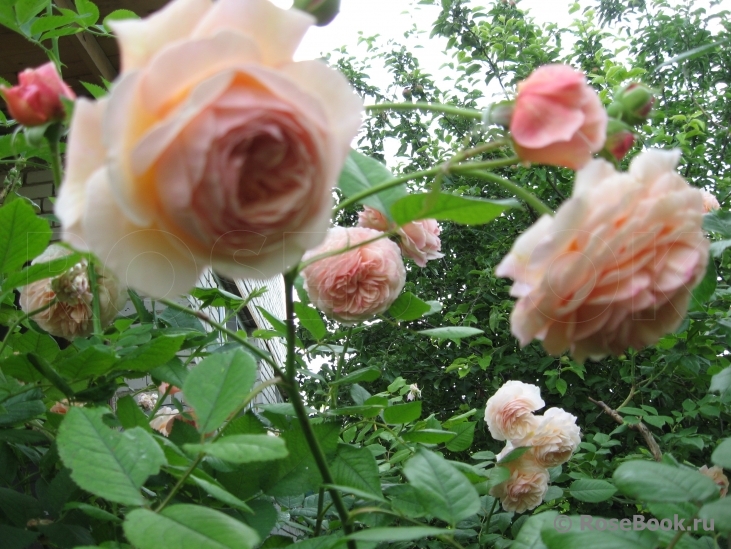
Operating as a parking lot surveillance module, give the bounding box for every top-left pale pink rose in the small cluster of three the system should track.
[485,380,546,440]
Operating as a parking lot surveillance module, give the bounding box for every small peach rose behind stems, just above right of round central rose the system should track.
[358,206,444,267]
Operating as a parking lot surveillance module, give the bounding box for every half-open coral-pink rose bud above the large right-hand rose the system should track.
[510,65,607,169]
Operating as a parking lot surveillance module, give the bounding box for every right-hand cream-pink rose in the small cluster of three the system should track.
[513,408,581,467]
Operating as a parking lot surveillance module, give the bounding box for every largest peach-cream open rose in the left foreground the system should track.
[56,0,362,297]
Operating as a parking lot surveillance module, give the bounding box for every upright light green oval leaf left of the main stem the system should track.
[183,349,257,433]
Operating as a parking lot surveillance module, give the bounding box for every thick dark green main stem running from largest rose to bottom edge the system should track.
[284,270,357,549]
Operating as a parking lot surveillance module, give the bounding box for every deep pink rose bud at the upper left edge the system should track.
[0,63,76,126]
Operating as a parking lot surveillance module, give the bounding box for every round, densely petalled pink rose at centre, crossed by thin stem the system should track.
[302,227,406,323]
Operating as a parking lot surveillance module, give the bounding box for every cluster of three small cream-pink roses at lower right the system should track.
[485,381,581,513]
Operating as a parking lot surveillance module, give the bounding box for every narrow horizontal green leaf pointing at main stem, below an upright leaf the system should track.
[185,435,288,463]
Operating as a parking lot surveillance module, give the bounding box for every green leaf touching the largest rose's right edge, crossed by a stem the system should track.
[338,150,406,219]
